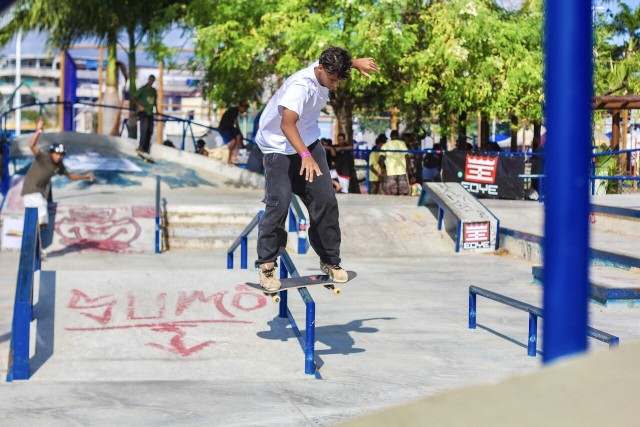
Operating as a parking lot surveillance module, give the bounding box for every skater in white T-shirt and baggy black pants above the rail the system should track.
[255,47,378,290]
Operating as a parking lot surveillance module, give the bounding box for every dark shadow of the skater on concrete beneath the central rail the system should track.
[257,317,395,356]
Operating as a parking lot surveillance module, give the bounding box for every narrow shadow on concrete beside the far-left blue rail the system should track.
[29,271,56,376]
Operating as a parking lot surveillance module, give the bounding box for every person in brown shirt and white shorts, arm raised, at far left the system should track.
[21,118,93,255]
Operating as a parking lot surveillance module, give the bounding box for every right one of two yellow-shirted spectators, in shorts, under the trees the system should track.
[380,130,409,196]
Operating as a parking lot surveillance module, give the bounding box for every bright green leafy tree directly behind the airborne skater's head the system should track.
[188,0,413,144]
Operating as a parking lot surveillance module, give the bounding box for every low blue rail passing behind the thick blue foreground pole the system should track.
[469,286,620,357]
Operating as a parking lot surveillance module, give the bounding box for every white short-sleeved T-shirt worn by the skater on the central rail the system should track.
[256,62,329,155]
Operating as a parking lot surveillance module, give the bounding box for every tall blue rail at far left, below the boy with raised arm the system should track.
[7,208,40,382]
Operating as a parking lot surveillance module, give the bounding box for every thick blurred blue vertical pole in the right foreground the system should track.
[543,0,593,363]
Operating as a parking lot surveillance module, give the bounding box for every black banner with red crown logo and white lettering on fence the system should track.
[442,151,524,200]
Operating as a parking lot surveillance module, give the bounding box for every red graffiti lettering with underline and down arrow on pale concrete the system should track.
[65,285,267,357]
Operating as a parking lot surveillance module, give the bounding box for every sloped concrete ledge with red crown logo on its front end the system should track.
[421,182,500,252]
